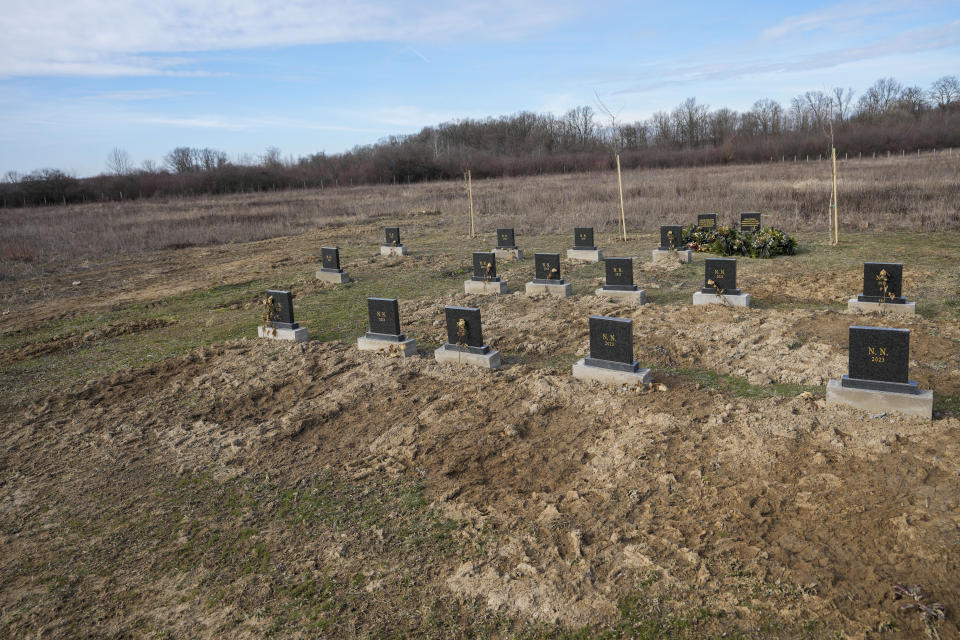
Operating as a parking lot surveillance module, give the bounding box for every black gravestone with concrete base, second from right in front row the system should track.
[573,316,650,384]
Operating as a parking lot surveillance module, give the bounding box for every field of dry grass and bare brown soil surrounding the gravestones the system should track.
[0,156,960,639]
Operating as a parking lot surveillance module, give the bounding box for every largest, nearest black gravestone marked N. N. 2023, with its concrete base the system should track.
[827,326,933,419]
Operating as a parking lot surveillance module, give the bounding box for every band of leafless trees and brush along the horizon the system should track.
[0,76,960,207]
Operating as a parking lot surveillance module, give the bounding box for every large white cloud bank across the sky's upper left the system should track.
[0,0,571,76]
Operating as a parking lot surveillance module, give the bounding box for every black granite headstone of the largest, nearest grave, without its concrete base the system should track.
[840,327,920,394]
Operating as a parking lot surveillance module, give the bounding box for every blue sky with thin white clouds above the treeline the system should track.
[0,0,960,176]
